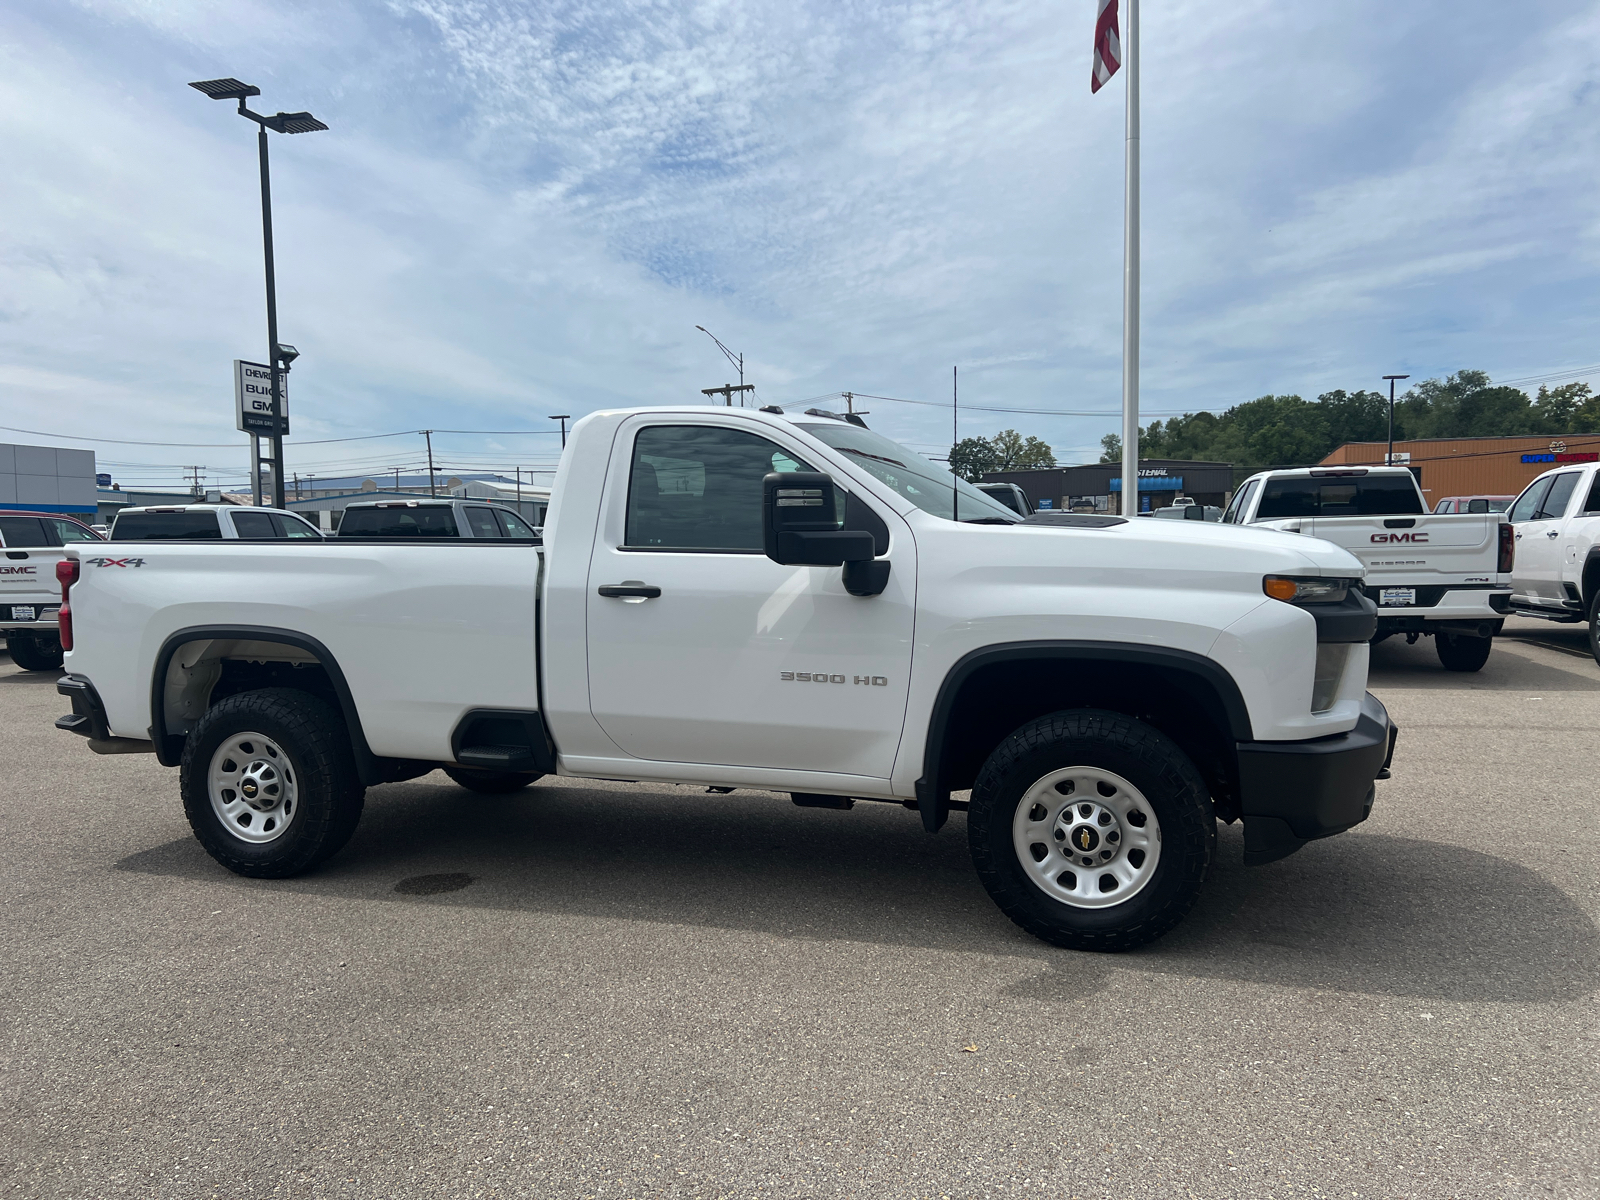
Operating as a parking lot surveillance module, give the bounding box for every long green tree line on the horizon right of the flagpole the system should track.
[1101,371,1600,472]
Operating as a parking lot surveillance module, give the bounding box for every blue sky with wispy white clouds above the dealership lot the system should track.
[0,0,1600,485]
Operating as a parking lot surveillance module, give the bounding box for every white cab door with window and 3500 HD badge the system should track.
[587,414,917,779]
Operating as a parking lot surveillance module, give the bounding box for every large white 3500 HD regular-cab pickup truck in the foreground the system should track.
[58,408,1395,949]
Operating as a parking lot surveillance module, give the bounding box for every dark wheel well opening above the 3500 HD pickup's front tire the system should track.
[926,656,1242,821]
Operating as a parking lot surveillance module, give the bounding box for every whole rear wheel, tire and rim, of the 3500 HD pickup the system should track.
[179,688,366,878]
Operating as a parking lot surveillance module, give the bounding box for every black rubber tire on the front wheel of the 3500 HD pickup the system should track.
[966,709,1216,950]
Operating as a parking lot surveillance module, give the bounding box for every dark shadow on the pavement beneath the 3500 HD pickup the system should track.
[117,776,1600,1002]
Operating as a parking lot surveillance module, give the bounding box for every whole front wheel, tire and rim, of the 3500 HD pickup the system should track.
[966,709,1216,950]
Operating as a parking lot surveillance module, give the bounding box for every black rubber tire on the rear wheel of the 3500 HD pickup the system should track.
[178,688,366,878]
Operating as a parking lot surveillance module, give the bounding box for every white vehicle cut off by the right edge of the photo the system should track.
[1510,454,1600,662]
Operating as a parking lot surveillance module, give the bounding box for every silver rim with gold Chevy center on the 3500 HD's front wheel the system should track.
[1011,766,1162,909]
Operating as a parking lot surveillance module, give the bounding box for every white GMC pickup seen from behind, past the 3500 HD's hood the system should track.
[1222,467,1514,670]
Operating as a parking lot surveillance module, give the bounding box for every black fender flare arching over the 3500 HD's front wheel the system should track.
[915,640,1254,834]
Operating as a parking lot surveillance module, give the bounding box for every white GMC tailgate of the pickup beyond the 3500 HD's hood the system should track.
[1301,512,1504,586]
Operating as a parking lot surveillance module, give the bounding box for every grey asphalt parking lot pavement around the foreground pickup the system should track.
[0,621,1600,1198]
